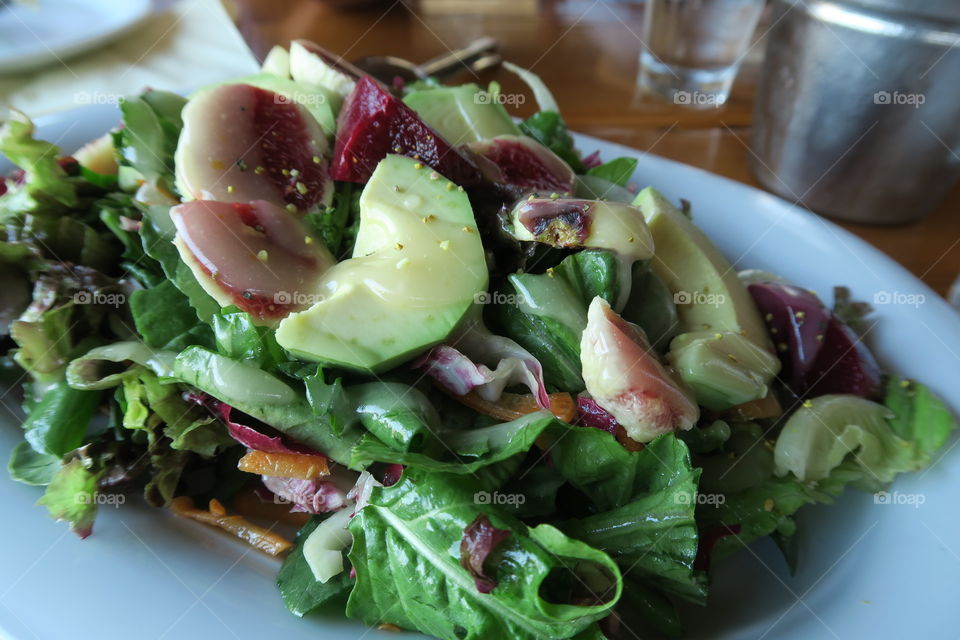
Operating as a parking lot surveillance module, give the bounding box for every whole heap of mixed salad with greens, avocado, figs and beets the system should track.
[0,41,956,640]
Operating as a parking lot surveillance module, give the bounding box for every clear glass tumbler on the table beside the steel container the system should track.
[640,0,764,109]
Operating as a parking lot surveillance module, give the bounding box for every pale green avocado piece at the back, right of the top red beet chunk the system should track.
[403,84,520,145]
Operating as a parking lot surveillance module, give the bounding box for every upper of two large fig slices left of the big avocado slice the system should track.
[175,84,333,211]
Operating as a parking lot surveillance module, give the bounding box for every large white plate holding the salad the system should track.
[0,105,960,640]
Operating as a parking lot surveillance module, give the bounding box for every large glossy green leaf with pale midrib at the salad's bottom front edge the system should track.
[347,472,621,640]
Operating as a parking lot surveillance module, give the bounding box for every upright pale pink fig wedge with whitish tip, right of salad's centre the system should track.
[580,296,700,442]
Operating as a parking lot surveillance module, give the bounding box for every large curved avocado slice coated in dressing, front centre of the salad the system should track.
[277,155,487,372]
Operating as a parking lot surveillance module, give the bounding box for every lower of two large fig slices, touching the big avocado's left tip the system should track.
[170,200,334,323]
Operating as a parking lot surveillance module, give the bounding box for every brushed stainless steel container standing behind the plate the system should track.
[751,0,960,224]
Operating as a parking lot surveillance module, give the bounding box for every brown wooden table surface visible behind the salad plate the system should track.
[230,0,960,295]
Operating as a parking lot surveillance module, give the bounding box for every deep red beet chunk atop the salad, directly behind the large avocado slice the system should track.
[330,76,481,186]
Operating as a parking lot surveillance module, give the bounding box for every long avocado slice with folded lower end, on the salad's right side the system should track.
[633,187,780,411]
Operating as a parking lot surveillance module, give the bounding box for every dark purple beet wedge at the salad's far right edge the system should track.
[747,282,880,398]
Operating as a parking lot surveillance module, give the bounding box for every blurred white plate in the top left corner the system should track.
[0,0,152,73]
